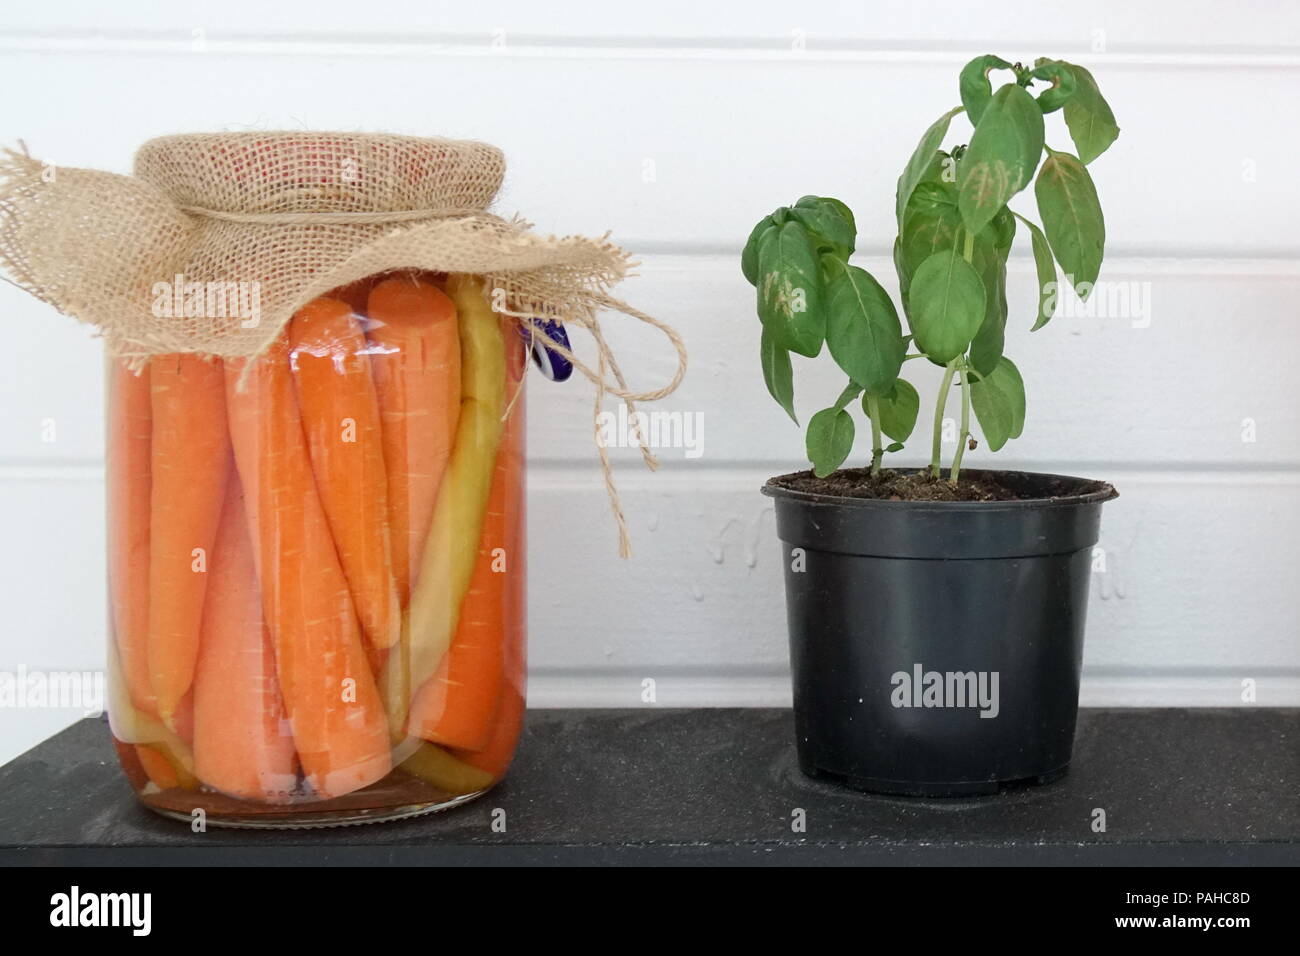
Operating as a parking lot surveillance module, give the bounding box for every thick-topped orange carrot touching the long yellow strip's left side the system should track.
[367,276,460,606]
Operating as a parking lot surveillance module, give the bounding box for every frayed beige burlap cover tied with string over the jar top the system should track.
[0,133,686,555]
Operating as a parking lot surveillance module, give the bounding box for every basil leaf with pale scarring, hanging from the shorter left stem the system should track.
[758,221,826,358]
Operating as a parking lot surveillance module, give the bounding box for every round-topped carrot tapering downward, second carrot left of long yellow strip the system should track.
[289,299,402,658]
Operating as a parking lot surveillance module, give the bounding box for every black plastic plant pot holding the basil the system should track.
[763,470,1117,796]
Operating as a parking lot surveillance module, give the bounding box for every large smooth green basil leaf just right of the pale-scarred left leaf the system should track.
[826,265,905,389]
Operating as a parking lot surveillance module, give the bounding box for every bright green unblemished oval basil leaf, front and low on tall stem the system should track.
[907,248,985,364]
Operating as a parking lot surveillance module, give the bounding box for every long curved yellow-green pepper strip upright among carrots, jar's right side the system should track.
[381,276,506,737]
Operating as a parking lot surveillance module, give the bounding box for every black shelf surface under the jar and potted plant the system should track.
[0,708,1300,866]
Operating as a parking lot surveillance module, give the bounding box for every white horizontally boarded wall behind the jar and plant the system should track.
[0,0,1300,760]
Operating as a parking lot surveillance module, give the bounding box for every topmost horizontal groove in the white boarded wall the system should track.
[0,32,1300,70]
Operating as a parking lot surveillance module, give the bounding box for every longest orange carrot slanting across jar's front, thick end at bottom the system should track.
[226,339,391,797]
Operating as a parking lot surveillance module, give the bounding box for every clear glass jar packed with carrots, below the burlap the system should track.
[107,272,525,827]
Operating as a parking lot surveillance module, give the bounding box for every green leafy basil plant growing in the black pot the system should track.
[741,55,1119,484]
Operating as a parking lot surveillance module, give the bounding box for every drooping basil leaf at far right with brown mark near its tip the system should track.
[1034,152,1106,299]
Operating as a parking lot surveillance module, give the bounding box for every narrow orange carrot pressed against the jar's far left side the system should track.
[107,362,157,714]
